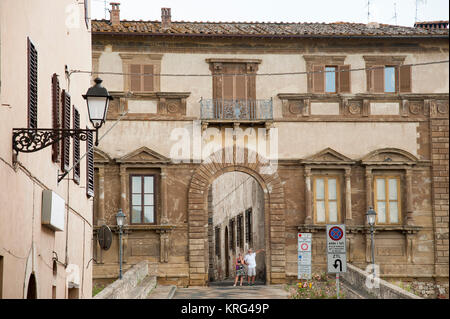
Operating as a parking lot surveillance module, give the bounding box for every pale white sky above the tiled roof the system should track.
[91,0,449,26]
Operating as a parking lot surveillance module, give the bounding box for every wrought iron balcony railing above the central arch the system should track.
[200,99,273,121]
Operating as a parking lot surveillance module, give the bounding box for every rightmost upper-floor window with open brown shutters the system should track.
[363,56,412,93]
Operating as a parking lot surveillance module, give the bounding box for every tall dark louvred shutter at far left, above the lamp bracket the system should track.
[28,38,38,128]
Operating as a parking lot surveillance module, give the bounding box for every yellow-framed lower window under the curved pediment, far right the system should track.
[374,176,401,224]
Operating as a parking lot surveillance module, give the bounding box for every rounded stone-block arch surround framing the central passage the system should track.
[188,147,286,286]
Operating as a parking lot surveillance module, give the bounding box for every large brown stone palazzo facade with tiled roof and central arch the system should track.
[92,5,449,285]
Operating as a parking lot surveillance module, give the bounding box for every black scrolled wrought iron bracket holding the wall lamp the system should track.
[12,128,97,154]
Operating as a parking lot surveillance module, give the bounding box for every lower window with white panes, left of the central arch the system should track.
[131,175,155,224]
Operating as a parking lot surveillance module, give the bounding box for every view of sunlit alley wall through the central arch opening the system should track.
[208,171,266,283]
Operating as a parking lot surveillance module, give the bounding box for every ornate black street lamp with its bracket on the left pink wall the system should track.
[12,78,113,154]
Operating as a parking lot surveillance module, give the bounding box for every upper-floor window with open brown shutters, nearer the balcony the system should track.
[303,55,351,93]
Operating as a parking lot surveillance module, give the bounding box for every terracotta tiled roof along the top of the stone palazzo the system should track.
[92,20,449,37]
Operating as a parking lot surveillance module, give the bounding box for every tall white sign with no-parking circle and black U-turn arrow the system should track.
[326,225,347,273]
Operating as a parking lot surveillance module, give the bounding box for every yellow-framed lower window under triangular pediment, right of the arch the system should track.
[313,176,340,224]
